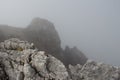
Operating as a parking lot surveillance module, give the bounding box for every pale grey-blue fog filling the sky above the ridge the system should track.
[0,0,120,65]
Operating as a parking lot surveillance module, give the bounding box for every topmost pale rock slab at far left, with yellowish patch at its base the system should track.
[0,38,34,51]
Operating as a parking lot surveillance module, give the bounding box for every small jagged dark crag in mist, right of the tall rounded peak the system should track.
[64,46,87,65]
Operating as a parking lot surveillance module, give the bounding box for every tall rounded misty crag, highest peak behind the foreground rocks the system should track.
[24,18,61,57]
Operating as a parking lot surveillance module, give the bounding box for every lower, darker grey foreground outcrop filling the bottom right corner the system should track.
[69,60,120,80]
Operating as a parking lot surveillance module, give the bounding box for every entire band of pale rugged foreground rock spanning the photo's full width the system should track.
[0,38,120,80]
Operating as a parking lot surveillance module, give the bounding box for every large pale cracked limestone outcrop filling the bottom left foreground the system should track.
[0,38,69,80]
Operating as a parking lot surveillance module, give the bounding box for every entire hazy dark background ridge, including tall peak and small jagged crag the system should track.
[0,18,87,65]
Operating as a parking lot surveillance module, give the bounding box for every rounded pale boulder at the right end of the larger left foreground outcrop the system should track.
[46,56,68,80]
